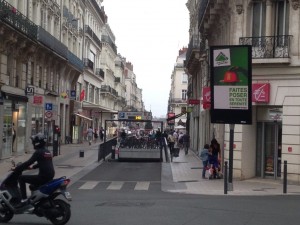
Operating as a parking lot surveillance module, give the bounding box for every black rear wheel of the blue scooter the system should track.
[49,199,71,225]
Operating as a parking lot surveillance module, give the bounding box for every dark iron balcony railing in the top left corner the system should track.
[0,0,37,41]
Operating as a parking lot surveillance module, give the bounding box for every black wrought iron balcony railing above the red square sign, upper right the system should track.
[240,35,292,59]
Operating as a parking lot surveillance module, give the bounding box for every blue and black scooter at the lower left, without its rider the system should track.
[0,161,72,225]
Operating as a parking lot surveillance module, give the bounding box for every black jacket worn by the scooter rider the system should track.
[15,148,55,179]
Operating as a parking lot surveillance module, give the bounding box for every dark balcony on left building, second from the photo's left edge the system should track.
[37,26,68,58]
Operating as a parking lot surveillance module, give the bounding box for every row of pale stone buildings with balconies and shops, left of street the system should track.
[0,0,142,159]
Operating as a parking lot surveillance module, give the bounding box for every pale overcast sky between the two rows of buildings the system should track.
[102,0,189,117]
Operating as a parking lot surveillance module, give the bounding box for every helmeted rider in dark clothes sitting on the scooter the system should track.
[14,133,55,205]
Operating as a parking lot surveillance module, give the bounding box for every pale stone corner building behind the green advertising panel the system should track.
[185,0,300,183]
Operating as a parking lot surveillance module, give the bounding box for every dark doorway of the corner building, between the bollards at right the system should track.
[256,121,282,179]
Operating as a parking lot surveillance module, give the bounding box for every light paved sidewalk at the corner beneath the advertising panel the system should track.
[163,151,300,196]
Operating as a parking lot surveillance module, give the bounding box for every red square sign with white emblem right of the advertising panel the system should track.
[252,83,270,103]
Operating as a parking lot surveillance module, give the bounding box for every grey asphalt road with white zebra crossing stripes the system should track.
[10,162,300,225]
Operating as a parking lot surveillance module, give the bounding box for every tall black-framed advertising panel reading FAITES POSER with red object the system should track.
[210,45,252,124]
